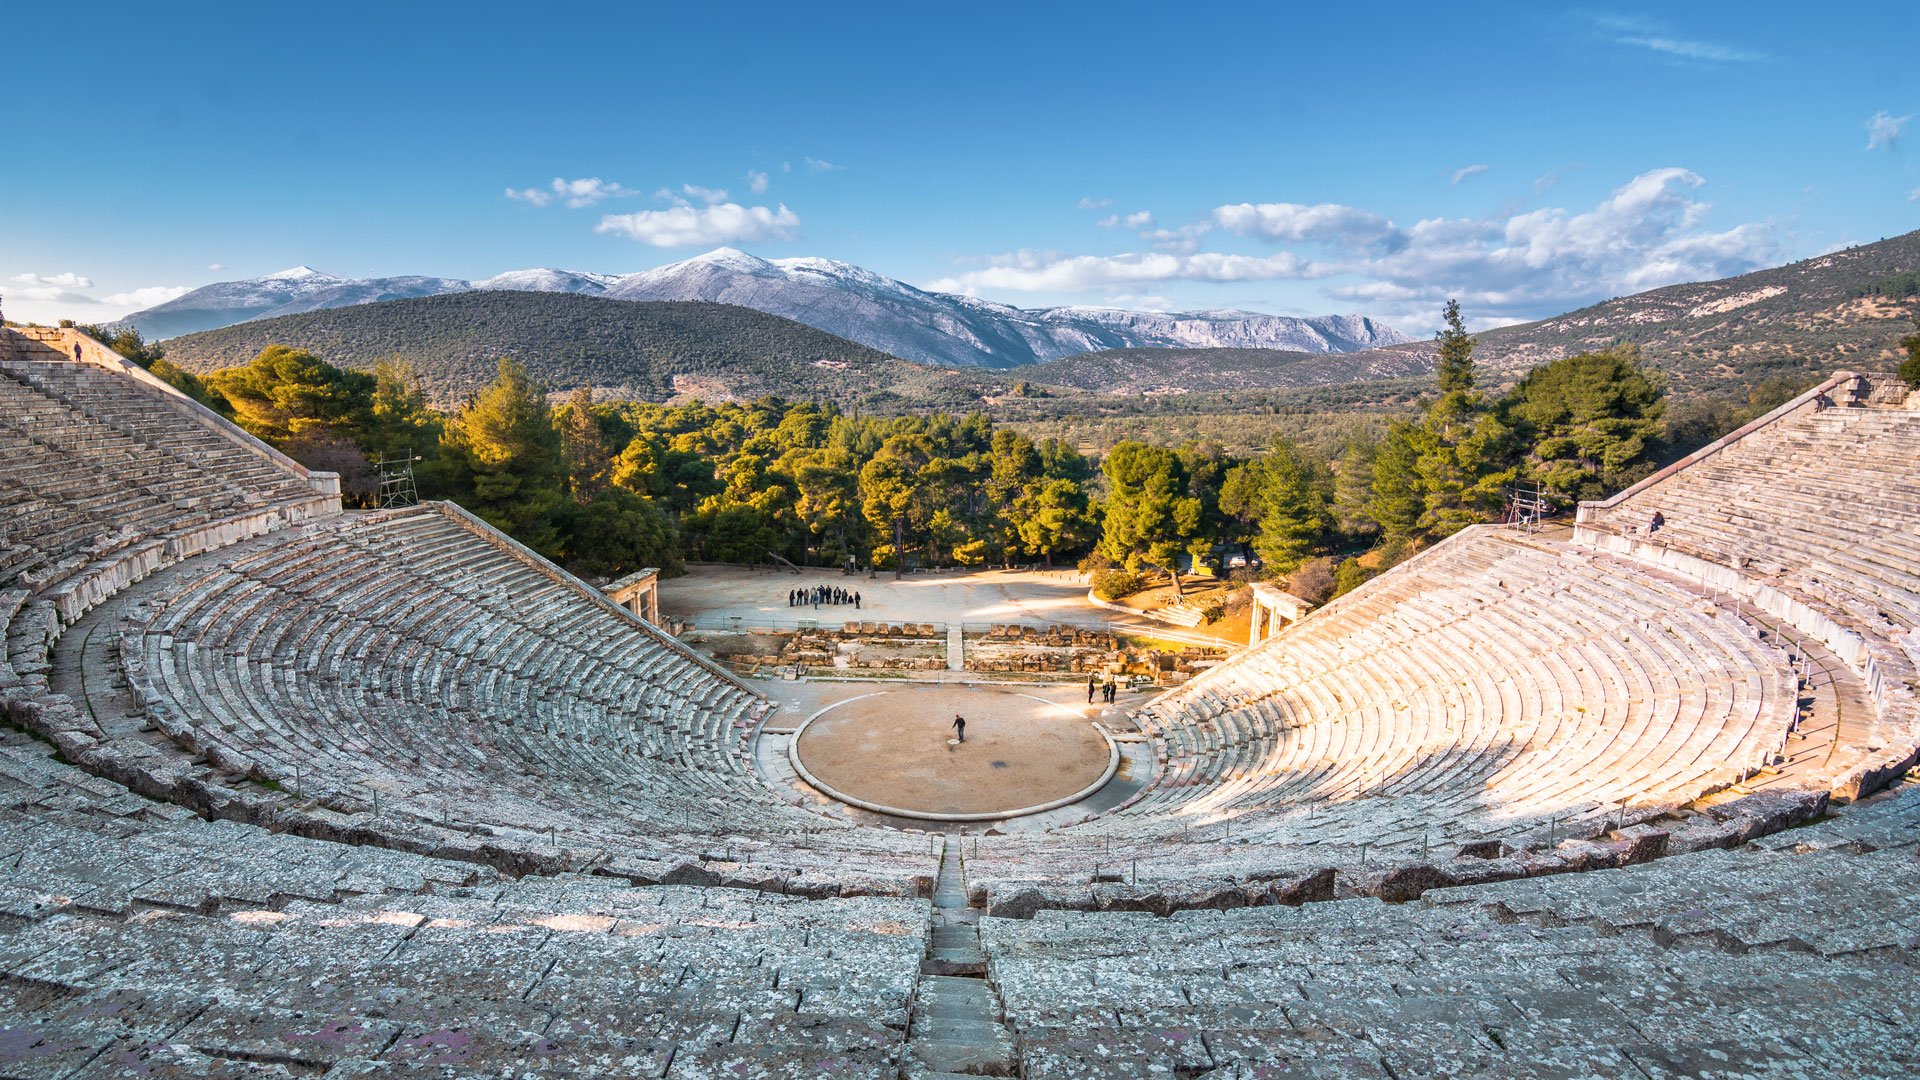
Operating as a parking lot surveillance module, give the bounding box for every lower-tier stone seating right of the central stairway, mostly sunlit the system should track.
[973,528,1795,892]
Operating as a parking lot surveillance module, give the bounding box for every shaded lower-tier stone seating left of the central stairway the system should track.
[104,505,929,892]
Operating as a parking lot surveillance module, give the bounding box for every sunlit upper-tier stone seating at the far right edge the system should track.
[1574,373,1920,794]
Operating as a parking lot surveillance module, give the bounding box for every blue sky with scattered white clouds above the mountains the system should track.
[0,2,1920,332]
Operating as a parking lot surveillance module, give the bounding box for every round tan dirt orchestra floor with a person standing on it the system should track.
[799,684,1108,813]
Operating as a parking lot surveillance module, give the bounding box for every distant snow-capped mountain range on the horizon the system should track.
[123,248,1409,367]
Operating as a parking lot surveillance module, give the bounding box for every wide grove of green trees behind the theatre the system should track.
[60,304,1795,600]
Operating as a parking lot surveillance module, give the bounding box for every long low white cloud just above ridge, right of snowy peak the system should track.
[927,250,1325,294]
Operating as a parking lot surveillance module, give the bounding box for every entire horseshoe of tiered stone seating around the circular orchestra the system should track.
[0,331,1920,1080]
